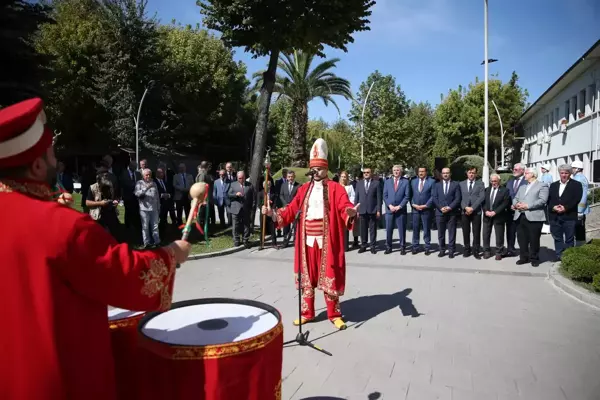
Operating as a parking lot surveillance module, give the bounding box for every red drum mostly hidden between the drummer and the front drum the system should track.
[108,308,145,400]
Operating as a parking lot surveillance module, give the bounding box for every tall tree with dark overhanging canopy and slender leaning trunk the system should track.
[197,0,375,189]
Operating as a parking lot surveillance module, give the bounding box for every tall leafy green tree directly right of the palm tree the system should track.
[350,71,410,170]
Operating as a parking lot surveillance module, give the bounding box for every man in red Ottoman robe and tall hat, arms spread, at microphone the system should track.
[262,139,358,329]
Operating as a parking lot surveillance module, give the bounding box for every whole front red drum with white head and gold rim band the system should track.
[138,299,283,400]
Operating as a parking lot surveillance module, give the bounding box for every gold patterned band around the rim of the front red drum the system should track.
[169,322,283,360]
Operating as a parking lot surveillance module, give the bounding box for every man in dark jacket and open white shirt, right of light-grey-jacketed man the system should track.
[548,164,583,261]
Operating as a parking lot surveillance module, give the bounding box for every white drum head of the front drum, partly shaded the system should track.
[139,299,281,346]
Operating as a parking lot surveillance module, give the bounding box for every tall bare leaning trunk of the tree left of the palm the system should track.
[250,50,279,194]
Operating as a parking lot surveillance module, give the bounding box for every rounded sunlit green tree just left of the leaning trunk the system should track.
[159,25,251,150]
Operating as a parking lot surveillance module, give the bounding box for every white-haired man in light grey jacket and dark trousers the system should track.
[511,168,549,267]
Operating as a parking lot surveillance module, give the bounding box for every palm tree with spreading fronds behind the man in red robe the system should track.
[254,50,352,168]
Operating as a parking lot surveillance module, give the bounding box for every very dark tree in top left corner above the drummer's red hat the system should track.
[0,0,51,107]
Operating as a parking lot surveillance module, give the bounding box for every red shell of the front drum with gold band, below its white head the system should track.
[139,300,283,400]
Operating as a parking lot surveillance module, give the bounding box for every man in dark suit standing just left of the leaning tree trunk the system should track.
[227,171,256,248]
